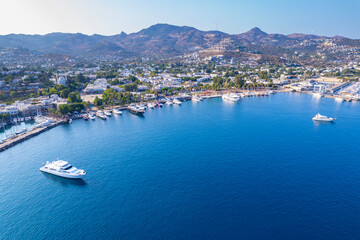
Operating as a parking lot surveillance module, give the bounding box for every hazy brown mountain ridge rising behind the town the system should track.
[0,23,360,56]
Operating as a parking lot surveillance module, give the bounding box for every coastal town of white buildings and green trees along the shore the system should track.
[0,56,360,150]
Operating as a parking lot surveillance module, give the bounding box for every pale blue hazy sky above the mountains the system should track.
[0,0,360,38]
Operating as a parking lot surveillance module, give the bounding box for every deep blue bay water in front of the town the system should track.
[0,93,360,240]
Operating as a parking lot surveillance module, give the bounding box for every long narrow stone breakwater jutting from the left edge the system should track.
[0,121,65,152]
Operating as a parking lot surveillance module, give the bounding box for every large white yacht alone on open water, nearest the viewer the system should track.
[40,159,86,178]
